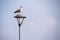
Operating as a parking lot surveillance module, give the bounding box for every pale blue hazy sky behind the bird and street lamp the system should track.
[0,0,60,40]
